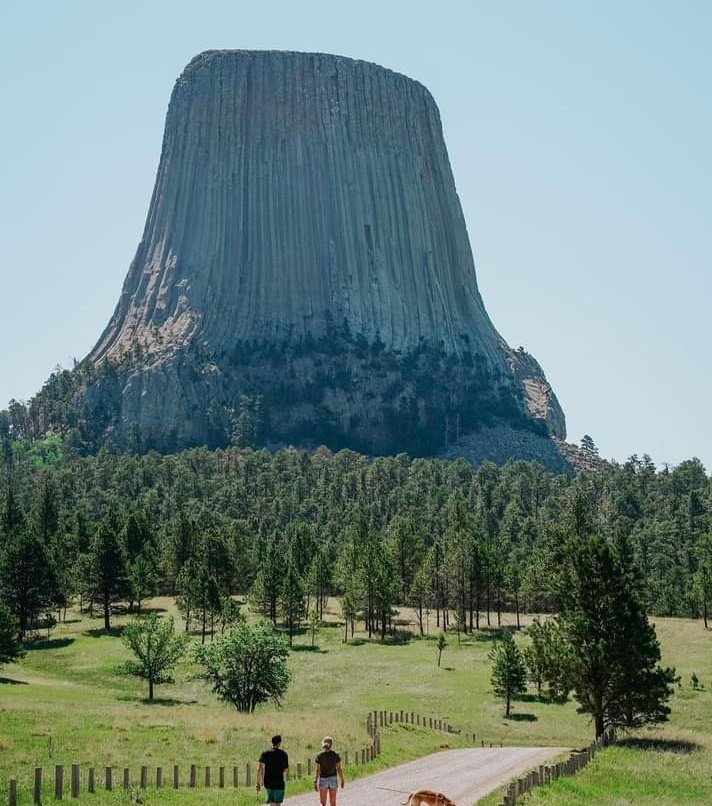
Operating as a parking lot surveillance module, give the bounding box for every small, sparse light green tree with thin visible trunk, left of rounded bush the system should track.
[121,613,188,700]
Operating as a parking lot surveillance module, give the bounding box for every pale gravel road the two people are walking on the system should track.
[285,747,562,806]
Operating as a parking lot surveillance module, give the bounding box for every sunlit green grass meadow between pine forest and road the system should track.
[0,599,712,806]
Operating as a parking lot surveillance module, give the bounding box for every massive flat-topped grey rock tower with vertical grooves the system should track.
[82,51,565,468]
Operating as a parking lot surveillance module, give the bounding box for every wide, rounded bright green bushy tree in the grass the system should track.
[195,624,290,713]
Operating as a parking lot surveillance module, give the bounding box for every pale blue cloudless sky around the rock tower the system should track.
[0,0,712,469]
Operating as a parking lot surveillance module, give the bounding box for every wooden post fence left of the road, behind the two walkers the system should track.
[8,711,456,806]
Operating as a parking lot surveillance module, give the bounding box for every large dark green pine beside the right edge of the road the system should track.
[557,508,677,736]
